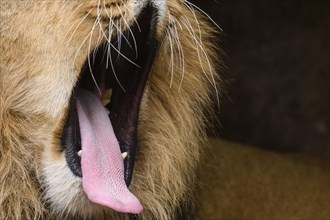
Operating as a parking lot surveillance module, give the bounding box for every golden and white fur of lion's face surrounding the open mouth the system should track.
[0,0,218,220]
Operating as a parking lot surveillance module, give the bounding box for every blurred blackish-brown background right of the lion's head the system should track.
[191,0,330,156]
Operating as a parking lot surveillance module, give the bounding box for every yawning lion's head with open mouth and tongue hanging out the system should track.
[0,0,219,220]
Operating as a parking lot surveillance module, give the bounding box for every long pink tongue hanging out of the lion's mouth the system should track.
[77,90,143,214]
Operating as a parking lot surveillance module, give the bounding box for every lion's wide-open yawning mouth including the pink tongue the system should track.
[62,6,157,213]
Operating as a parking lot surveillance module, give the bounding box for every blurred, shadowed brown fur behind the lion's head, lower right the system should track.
[198,140,330,220]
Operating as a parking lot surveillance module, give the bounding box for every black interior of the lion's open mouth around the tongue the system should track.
[62,6,157,185]
